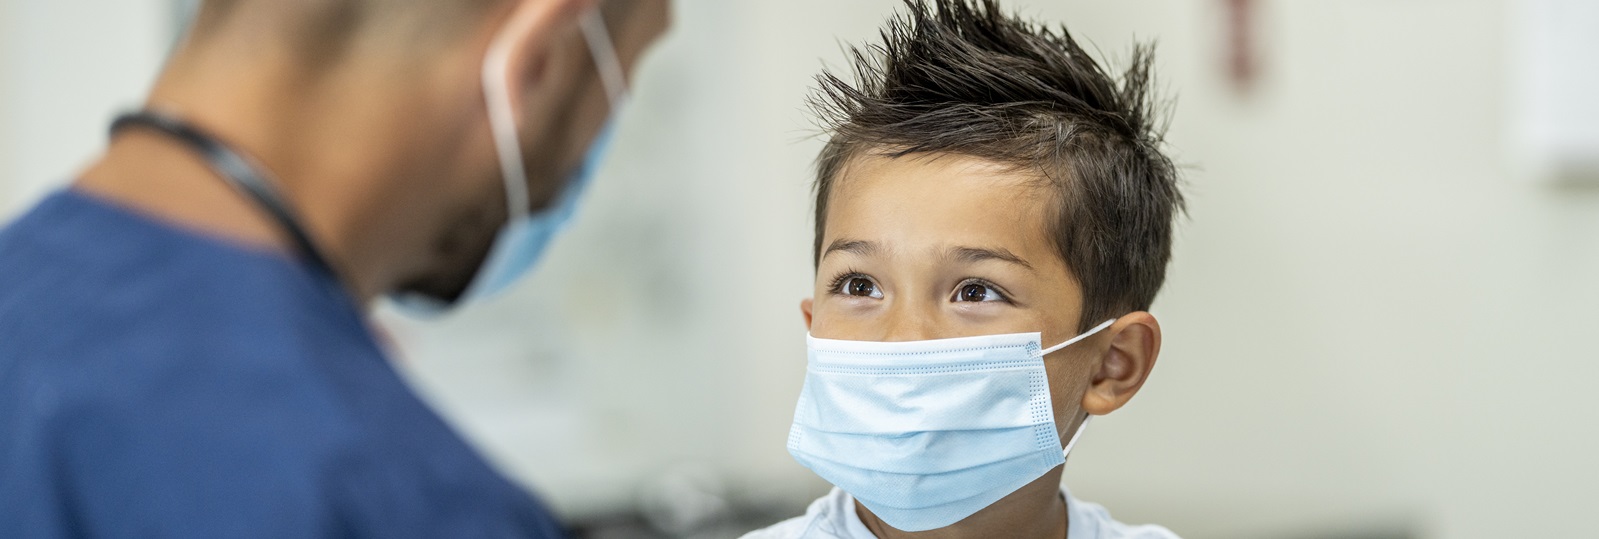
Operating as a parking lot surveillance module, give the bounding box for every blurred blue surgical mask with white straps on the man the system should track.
[395,10,627,315]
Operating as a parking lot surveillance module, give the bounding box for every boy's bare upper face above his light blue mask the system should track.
[803,154,1099,440]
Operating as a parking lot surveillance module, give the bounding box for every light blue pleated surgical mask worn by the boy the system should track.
[788,321,1111,531]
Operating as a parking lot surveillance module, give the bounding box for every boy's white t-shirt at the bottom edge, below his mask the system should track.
[742,486,1178,539]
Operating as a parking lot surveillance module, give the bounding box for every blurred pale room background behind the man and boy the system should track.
[0,0,1599,539]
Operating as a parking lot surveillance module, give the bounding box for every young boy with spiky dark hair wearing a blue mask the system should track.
[747,0,1182,539]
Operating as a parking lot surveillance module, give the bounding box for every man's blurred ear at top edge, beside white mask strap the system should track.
[489,0,598,118]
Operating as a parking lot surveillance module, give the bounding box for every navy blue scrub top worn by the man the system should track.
[0,190,561,537]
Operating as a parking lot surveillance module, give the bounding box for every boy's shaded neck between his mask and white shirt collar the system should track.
[855,467,1067,539]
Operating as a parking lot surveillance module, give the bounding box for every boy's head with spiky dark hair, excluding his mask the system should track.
[803,0,1182,440]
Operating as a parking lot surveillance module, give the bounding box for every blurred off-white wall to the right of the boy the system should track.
[1029,2,1599,537]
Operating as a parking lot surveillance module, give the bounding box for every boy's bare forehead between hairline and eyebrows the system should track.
[823,154,1054,257]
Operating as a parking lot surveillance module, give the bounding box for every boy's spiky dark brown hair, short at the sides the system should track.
[811,0,1183,329]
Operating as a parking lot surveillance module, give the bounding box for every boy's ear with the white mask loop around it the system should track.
[1083,310,1161,416]
